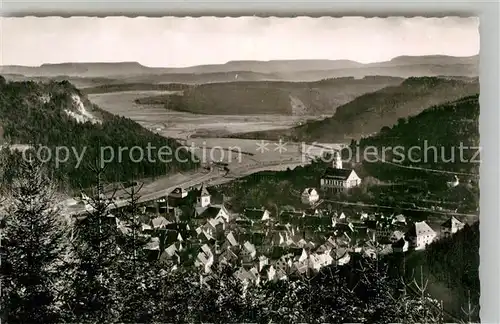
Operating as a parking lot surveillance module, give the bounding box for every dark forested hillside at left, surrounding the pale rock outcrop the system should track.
[0,80,196,188]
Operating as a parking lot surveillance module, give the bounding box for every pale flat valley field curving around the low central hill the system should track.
[88,91,310,139]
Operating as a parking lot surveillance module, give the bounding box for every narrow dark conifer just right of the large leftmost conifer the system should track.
[66,164,119,323]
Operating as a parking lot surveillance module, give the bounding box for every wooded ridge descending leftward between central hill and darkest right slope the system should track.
[232,77,479,143]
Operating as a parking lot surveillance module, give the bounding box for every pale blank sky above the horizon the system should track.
[0,17,479,67]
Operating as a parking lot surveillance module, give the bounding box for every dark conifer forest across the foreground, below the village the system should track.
[0,163,477,324]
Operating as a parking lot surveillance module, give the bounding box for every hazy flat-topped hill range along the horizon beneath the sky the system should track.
[0,55,479,83]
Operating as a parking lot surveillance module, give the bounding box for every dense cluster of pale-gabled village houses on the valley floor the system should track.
[102,185,464,284]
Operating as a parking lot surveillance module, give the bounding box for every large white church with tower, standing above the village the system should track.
[320,152,361,193]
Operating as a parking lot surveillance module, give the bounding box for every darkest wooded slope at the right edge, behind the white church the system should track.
[358,95,480,177]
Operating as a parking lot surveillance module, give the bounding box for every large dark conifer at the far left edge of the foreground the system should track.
[1,162,67,323]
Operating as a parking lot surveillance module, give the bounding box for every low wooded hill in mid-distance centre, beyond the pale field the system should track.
[136,76,403,115]
